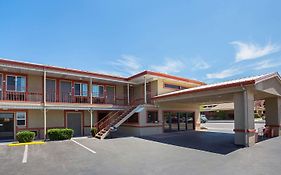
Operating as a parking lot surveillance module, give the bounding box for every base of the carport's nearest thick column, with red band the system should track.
[234,129,256,147]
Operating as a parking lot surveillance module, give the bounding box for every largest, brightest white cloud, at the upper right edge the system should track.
[230,41,280,62]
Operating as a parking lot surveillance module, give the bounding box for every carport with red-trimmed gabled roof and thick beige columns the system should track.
[154,73,281,146]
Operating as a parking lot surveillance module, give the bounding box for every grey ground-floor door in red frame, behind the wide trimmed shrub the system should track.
[66,112,82,137]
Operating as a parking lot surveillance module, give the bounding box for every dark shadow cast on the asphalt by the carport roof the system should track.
[139,131,243,155]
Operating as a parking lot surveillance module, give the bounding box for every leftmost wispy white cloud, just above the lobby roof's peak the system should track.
[111,54,142,75]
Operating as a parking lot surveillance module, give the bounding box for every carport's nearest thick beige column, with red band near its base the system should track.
[234,89,255,147]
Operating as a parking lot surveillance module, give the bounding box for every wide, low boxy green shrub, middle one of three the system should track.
[47,128,74,140]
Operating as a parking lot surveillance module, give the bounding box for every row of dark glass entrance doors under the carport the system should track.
[163,112,195,132]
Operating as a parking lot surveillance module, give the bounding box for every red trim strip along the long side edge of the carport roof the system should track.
[152,80,255,99]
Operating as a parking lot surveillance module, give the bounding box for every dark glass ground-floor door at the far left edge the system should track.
[0,113,14,140]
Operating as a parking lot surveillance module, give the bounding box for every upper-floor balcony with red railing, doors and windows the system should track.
[0,73,128,105]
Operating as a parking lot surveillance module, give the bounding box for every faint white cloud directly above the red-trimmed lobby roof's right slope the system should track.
[151,58,185,73]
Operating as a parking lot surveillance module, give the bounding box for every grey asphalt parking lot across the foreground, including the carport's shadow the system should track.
[0,121,281,175]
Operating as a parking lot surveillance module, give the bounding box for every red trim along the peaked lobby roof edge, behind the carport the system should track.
[127,71,205,85]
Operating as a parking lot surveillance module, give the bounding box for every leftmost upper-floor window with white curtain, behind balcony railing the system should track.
[7,75,26,92]
